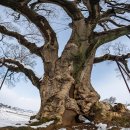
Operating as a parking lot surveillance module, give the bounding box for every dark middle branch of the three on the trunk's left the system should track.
[0,25,41,56]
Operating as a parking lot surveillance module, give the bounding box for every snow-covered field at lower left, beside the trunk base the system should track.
[0,107,34,127]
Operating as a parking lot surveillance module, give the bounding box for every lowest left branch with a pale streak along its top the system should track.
[0,58,40,88]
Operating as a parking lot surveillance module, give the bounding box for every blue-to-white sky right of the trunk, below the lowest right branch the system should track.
[92,62,130,103]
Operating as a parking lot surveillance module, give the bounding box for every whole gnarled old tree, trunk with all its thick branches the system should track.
[0,0,130,128]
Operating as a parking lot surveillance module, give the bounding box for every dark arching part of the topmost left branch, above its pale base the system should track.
[0,0,56,44]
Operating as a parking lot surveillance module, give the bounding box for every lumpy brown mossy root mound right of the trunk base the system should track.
[88,102,130,128]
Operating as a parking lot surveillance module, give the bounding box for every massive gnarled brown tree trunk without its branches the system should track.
[37,20,99,125]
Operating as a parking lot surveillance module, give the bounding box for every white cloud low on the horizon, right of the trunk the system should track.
[96,78,130,103]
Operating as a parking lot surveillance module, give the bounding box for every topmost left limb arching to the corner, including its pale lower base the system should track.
[0,0,58,67]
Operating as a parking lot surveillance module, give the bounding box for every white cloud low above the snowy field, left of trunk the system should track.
[0,86,40,111]
